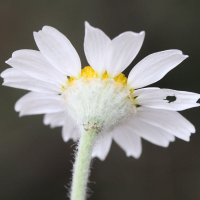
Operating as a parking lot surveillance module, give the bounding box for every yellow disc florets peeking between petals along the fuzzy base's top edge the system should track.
[69,66,127,86]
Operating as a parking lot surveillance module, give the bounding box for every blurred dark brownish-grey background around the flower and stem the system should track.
[0,0,200,200]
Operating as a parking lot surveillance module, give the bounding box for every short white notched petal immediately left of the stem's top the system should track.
[62,114,80,142]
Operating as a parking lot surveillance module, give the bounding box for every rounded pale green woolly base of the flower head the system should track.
[62,77,136,137]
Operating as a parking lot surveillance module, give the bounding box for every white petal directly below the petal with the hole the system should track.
[137,107,192,141]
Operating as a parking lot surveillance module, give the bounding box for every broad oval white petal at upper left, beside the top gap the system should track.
[34,26,81,77]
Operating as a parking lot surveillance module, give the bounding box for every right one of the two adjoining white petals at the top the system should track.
[105,31,145,78]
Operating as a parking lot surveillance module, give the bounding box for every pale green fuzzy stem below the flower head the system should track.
[71,129,97,200]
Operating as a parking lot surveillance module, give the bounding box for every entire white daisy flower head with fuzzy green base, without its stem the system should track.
[1,22,200,160]
